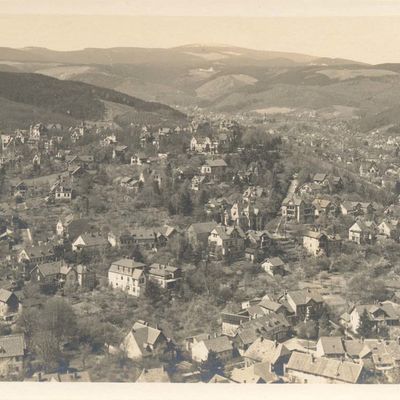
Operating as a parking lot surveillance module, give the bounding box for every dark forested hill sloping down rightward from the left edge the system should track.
[0,72,185,128]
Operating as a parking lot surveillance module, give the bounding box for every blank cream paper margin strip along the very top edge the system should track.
[0,0,400,16]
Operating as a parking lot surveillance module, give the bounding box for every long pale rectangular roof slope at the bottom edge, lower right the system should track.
[286,351,363,383]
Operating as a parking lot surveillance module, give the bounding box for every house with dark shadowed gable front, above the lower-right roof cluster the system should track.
[279,289,324,321]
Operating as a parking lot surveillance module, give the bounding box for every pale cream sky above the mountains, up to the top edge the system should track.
[0,0,400,63]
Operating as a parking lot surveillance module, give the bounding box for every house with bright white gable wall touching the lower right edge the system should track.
[348,303,400,333]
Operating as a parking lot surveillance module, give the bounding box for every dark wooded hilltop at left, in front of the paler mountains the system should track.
[0,71,184,127]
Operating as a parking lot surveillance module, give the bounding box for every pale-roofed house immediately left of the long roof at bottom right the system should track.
[243,337,290,375]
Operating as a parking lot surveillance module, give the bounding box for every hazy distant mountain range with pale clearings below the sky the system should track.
[0,44,400,129]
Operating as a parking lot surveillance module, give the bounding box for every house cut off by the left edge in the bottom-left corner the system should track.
[0,334,26,377]
